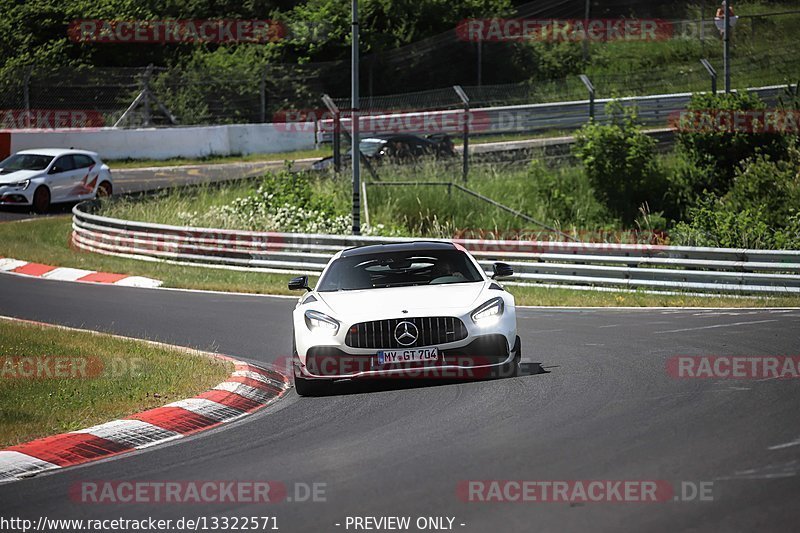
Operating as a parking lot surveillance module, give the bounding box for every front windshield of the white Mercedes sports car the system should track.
[317,250,483,292]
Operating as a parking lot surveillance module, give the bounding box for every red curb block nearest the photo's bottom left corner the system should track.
[6,433,133,466]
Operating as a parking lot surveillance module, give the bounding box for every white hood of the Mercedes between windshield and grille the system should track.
[317,282,487,322]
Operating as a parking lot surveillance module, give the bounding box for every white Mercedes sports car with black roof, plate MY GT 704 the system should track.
[289,241,521,395]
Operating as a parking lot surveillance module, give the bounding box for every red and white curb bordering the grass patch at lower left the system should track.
[0,320,290,483]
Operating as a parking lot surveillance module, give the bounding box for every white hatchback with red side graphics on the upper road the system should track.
[0,148,113,213]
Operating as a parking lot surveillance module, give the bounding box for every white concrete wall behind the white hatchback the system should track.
[11,124,314,159]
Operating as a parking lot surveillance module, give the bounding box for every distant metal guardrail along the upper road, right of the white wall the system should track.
[316,85,792,142]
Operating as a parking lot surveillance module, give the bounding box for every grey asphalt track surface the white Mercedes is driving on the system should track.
[0,275,800,532]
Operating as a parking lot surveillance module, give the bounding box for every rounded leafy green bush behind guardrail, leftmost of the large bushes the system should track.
[573,101,664,224]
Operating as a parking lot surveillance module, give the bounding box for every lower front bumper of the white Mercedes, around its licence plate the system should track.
[294,334,515,380]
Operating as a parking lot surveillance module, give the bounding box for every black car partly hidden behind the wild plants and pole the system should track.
[311,133,456,170]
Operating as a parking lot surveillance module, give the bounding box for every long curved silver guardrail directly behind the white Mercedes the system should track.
[72,202,800,295]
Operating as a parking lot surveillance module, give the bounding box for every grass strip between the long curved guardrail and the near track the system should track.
[0,217,800,308]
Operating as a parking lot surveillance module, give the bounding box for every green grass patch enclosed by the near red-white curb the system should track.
[0,320,233,447]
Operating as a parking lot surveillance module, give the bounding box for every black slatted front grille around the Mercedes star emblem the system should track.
[344,316,467,349]
